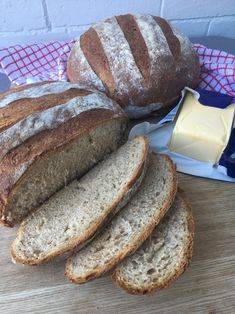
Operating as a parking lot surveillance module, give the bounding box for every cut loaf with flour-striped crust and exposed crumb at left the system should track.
[0,82,128,226]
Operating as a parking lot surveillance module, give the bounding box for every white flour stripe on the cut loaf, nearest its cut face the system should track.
[0,91,119,160]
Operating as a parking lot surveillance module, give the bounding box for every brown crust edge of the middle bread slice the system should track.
[65,153,177,283]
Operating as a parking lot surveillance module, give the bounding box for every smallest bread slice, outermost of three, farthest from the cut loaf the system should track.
[112,191,194,294]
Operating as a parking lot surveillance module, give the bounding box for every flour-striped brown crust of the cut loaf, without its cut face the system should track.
[0,82,127,226]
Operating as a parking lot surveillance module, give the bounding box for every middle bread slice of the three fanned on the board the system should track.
[65,153,177,283]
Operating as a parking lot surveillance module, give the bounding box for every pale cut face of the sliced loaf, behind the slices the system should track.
[0,117,127,227]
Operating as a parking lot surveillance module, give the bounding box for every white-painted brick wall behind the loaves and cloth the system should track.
[0,0,235,47]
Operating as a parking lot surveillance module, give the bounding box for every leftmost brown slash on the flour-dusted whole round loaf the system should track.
[80,27,115,97]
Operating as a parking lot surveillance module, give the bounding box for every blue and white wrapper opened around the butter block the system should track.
[129,87,235,182]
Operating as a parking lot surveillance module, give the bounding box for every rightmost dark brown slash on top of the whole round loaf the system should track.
[153,16,181,61]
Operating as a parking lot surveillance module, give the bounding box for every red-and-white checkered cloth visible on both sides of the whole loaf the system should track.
[0,40,235,98]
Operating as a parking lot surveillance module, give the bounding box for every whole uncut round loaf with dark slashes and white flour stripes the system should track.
[67,14,200,118]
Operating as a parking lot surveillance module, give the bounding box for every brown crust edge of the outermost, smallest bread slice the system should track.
[112,188,195,295]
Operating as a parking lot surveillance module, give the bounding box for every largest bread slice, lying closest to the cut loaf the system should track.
[12,136,149,265]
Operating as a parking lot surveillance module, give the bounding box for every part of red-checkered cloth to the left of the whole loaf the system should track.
[0,40,75,85]
